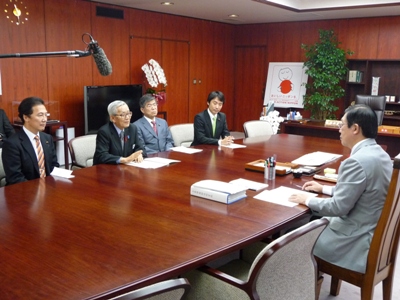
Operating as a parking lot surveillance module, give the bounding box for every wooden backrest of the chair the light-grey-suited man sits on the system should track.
[365,154,400,283]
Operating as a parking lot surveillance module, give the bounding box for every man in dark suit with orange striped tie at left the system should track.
[2,97,60,185]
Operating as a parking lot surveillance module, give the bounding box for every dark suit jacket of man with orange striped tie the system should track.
[2,129,60,185]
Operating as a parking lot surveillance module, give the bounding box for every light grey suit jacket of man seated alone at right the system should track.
[308,139,393,273]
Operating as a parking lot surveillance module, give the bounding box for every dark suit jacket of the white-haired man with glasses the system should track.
[93,122,146,165]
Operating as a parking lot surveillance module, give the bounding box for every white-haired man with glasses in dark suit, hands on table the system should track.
[93,100,146,165]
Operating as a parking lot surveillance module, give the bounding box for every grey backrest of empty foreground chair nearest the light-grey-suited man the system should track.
[248,218,329,300]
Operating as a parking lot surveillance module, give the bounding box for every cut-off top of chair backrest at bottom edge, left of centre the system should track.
[110,278,190,300]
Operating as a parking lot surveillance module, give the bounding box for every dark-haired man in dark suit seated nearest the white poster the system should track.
[192,91,233,146]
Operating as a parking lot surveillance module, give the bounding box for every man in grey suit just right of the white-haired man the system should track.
[133,94,174,154]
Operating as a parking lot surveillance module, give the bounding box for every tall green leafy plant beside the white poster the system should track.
[301,29,353,120]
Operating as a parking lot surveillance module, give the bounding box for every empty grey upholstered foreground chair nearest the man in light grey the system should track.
[185,219,328,300]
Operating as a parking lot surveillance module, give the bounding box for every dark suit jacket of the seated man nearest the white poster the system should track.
[191,109,230,146]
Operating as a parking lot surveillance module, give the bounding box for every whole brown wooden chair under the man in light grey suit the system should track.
[316,158,400,300]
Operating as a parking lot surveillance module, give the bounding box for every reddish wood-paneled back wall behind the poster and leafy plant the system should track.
[233,16,400,130]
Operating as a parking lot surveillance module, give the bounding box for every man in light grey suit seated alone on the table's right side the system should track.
[290,105,392,273]
